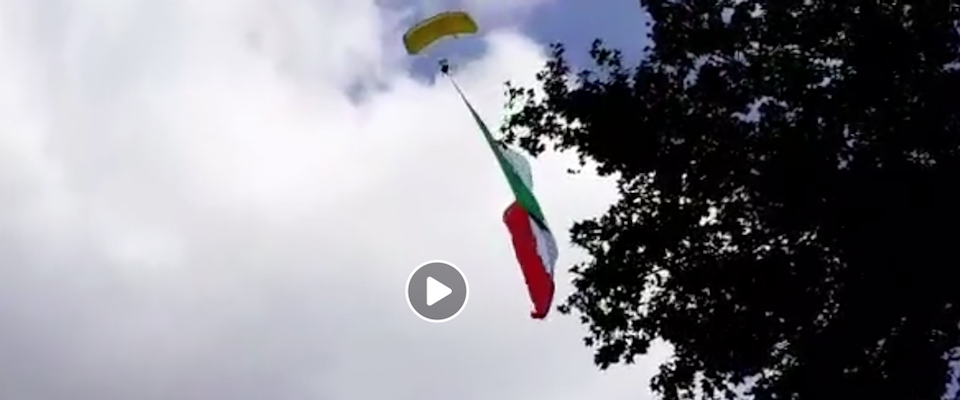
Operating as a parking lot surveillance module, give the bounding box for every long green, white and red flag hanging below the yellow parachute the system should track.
[451,78,558,319]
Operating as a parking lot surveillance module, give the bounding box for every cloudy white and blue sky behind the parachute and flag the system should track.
[0,0,668,400]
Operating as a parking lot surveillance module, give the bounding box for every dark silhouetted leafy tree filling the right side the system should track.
[503,0,960,400]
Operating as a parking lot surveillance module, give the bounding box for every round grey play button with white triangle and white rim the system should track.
[407,261,469,322]
